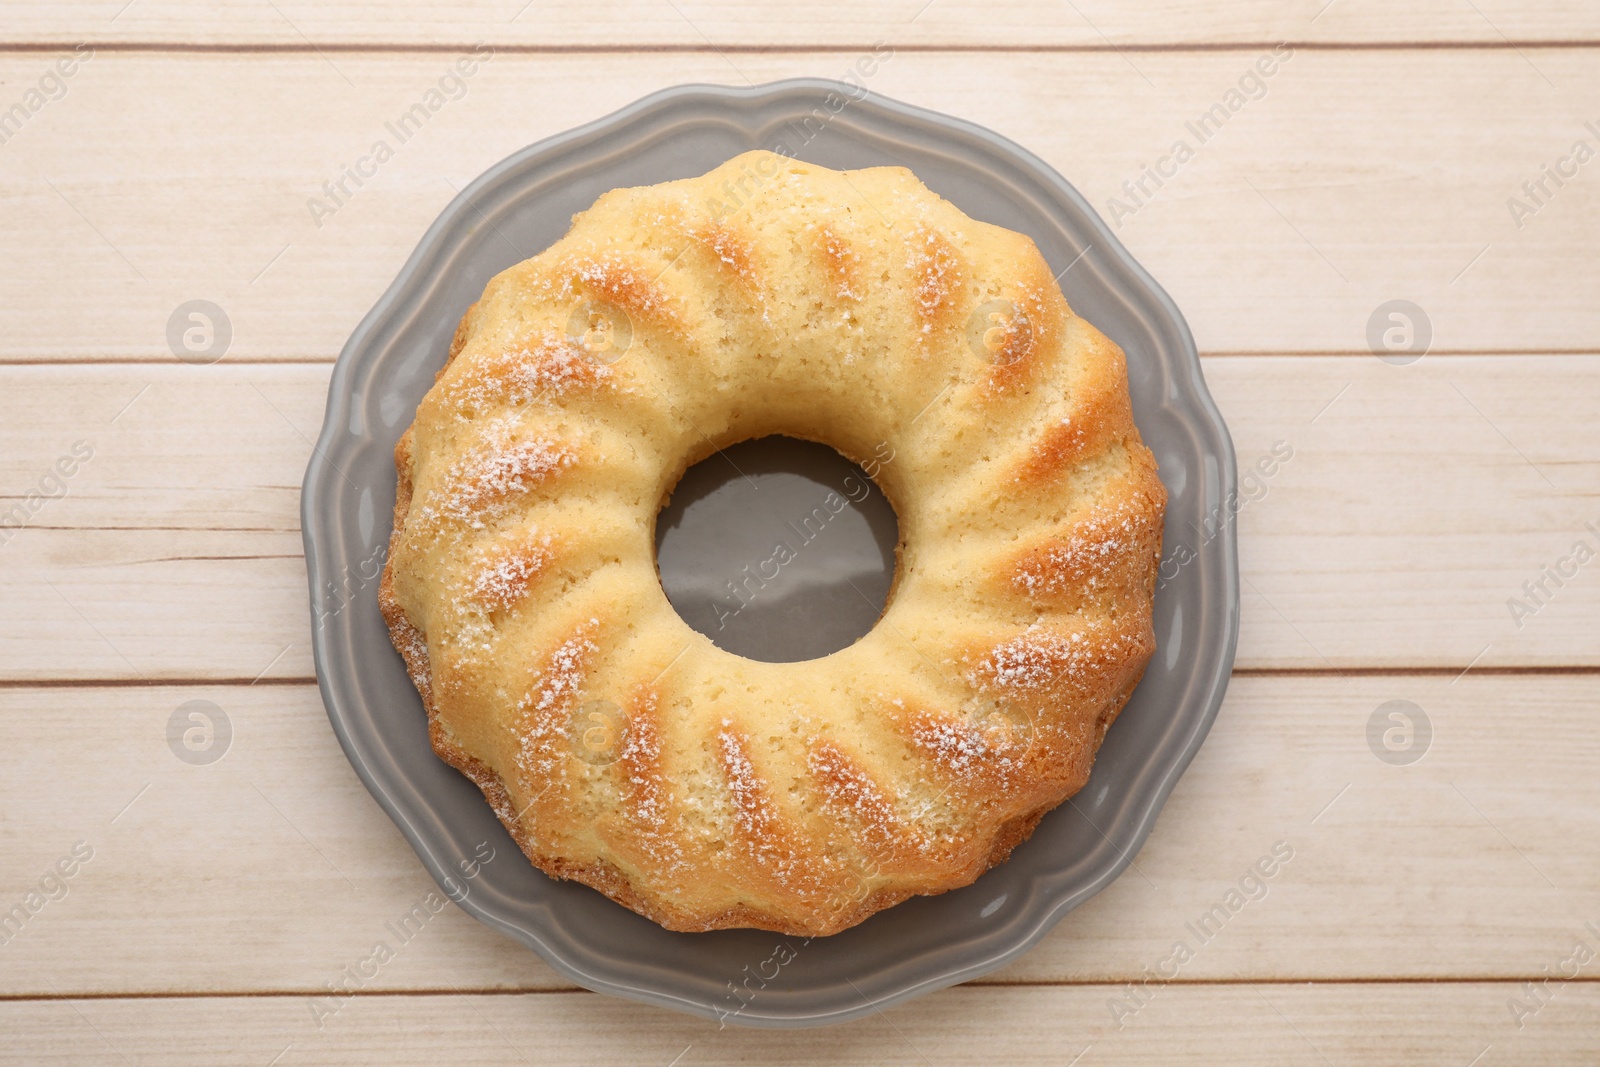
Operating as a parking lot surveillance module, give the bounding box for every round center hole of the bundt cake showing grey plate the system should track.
[656,437,899,662]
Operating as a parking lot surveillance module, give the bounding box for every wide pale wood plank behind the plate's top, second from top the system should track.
[0,49,1600,362]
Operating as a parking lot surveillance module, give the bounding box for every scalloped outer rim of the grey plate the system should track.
[301,78,1238,1027]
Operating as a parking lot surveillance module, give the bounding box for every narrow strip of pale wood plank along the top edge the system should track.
[9,0,1600,50]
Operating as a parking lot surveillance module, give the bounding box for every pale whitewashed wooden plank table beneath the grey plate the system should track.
[0,0,1600,1067]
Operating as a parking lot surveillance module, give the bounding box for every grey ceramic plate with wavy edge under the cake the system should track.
[301,80,1238,1025]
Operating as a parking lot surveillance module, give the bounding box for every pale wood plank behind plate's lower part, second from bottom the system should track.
[0,675,1600,998]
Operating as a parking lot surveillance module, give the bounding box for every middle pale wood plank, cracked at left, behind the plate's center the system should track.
[0,355,1600,681]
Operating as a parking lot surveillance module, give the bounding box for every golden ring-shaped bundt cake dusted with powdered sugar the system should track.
[381,152,1166,936]
